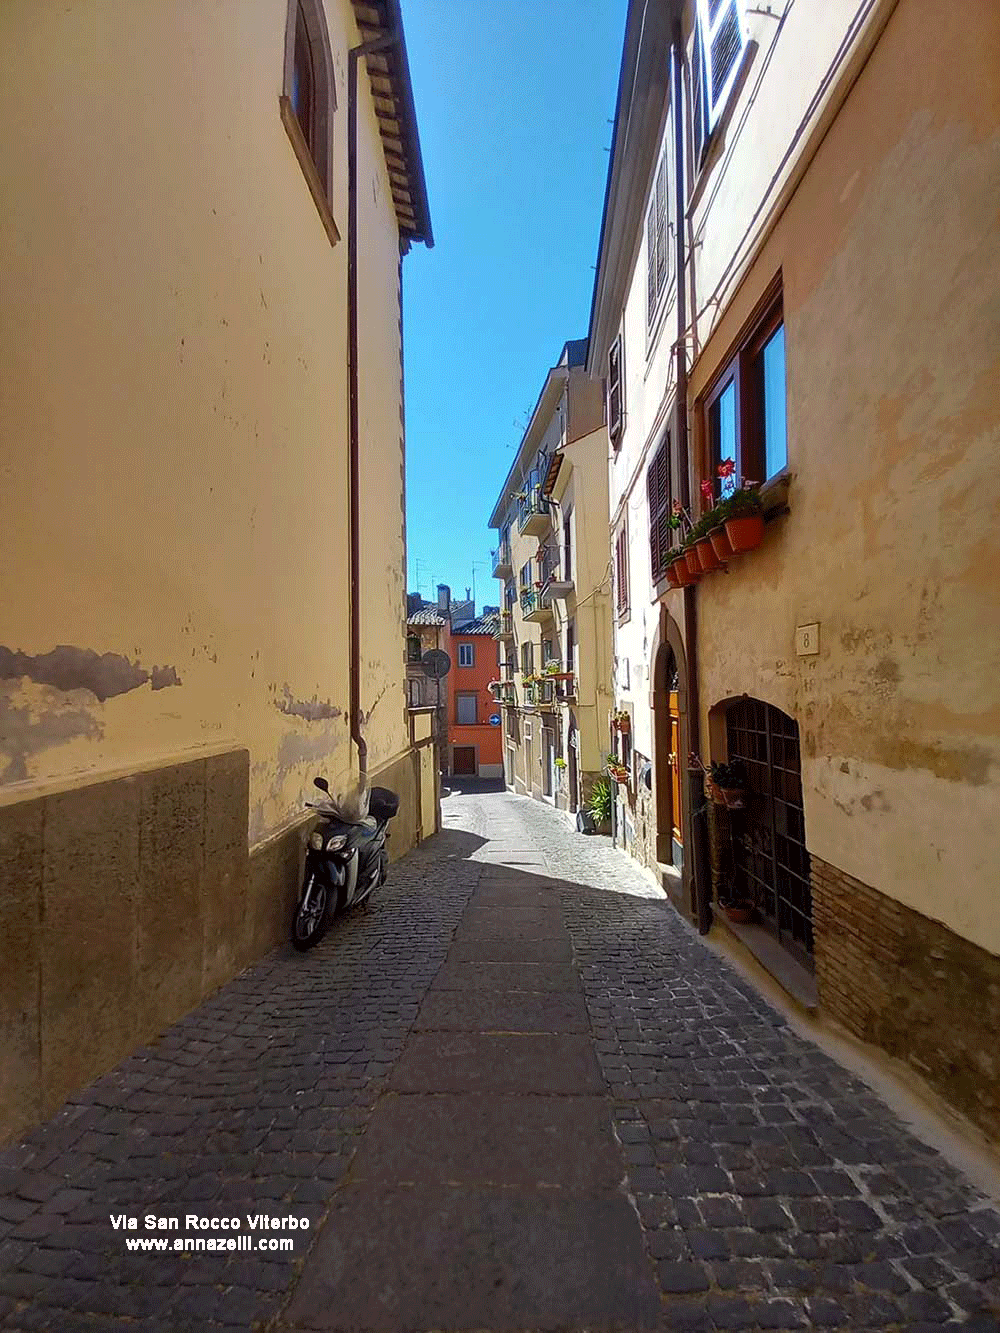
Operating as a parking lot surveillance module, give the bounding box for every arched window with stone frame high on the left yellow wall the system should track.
[280,0,340,245]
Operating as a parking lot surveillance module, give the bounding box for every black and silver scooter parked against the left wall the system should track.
[292,777,399,949]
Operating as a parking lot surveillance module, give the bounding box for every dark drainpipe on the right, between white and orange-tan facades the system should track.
[673,19,712,934]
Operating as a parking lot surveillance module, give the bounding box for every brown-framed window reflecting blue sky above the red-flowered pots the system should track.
[704,296,788,499]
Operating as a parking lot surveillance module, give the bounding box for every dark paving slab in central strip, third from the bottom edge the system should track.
[389,1032,607,1094]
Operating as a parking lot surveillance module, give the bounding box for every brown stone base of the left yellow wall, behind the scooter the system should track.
[0,748,439,1142]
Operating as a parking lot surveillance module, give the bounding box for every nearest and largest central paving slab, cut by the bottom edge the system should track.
[285,1185,660,1333]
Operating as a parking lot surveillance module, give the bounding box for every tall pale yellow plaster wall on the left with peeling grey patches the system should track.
[0,0,407,842]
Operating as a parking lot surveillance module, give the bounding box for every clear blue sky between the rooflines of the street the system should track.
[403,0,625,605]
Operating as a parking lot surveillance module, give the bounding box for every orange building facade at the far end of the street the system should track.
[447,615,504,777]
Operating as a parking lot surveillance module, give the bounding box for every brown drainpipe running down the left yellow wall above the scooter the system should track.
[347,32,399,778]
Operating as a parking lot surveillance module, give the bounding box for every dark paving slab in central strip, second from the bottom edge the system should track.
[351,1093,624,1193]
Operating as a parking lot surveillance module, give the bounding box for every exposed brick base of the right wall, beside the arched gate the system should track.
[812,856,1000,1142]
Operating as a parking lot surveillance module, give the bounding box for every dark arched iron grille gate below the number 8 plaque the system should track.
[725,698,813,968]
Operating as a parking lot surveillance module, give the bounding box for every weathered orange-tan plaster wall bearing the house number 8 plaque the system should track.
[692,0,1000,953]
